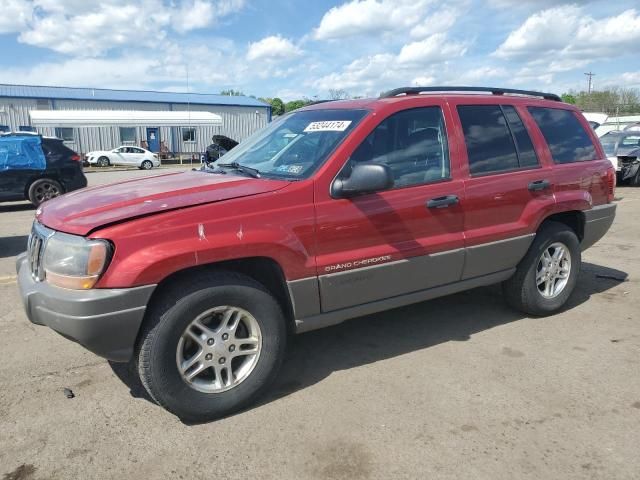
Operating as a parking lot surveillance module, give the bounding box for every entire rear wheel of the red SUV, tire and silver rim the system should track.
[502,221,581,316]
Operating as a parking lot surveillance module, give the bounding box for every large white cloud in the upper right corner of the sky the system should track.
[494,5,640,61]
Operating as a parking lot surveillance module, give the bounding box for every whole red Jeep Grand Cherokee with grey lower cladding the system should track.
[17,87,616,421]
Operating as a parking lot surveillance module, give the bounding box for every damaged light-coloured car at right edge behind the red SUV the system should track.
[600,130,640,187]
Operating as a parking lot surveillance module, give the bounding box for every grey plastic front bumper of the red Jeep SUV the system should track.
[16,253,156,362]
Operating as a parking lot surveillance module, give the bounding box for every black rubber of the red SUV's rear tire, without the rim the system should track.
[502,221,581,316]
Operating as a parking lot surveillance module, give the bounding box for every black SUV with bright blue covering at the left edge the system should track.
[0,132,87,206]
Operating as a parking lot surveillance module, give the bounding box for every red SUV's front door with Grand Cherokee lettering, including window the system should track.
[316,105,464,312]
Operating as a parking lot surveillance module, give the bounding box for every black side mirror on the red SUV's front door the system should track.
[331,162,393,198]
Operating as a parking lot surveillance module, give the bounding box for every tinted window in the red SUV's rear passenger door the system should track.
[458,105,538,175]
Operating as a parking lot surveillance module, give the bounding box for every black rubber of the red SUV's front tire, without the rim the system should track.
[135,271,287,422]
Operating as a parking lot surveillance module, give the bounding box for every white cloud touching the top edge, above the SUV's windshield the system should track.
[314,0,434,40]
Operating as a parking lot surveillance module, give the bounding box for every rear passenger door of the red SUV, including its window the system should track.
[453,103,554,279]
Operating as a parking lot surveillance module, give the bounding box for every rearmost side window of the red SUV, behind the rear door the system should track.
[527,107,596,163]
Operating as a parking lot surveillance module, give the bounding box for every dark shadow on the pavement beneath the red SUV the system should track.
[111,263,627,424]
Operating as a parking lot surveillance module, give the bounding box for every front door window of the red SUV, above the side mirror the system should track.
[341,107,449,188]
